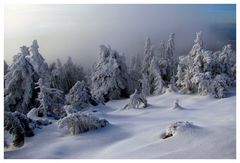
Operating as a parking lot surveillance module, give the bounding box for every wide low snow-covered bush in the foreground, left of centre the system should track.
[57,112,109,135]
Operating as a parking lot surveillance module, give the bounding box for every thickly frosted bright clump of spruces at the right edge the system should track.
[176,32,236,98]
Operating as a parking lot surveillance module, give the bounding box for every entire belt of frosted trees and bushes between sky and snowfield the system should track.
[4,32,236,146]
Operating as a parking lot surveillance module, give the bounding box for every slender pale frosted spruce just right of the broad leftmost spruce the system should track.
[27,40,50,86]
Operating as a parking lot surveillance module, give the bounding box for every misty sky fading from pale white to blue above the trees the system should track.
[4,4,236,68]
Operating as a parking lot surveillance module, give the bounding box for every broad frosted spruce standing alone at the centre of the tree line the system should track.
[91,45,131,102]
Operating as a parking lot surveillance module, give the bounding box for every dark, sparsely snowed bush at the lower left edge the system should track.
[4,111,35,147]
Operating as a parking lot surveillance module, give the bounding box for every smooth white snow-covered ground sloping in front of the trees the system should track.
[4,91,236,159]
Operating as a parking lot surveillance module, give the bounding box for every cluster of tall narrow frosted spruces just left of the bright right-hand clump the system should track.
[141,33,177,96]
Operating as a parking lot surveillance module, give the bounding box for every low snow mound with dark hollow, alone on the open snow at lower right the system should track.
[161,121,199,139]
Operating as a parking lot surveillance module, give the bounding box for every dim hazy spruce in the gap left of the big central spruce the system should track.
[62,57,86,93]
